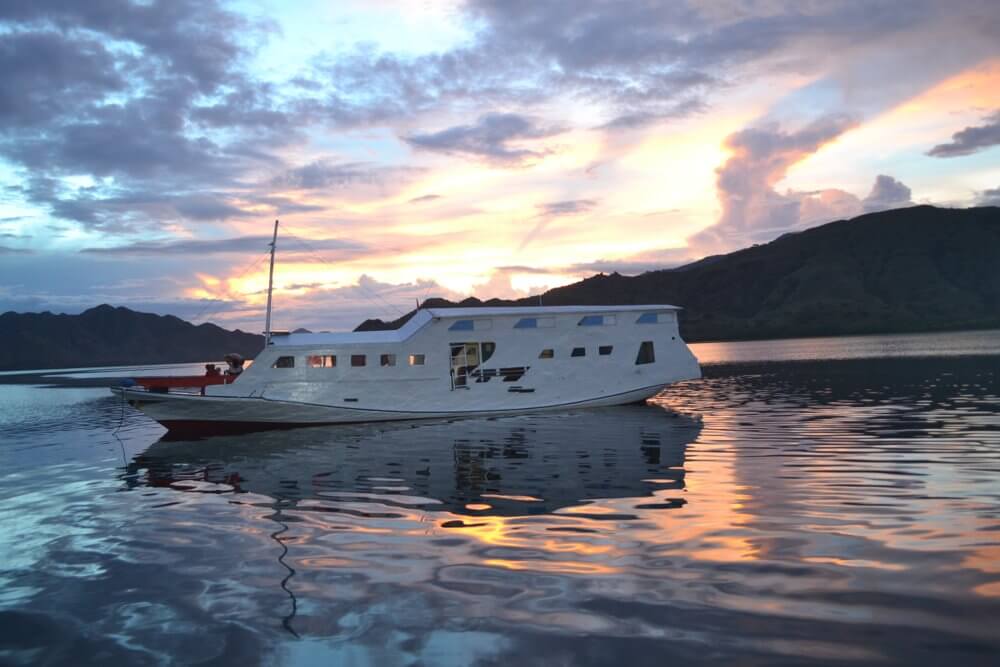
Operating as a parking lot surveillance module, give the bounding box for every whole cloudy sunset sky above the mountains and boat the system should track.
[0,0,1000,331]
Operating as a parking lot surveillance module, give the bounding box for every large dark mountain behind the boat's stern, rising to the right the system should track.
[358,206,1000,342]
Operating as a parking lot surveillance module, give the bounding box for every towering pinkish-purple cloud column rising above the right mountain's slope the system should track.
[689,115,857,252]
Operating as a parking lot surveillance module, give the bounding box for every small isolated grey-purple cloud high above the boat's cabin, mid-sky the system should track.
[404,113,563,166]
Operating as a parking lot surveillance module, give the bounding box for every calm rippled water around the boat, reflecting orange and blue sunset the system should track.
[0,332,1000,665]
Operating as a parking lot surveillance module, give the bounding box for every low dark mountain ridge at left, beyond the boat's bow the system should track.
[0,305,264,370]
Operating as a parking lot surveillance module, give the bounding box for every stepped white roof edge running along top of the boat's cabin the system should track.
[271,304,680,347]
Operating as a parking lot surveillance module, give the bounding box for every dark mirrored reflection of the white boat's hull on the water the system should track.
[125,405,701,516]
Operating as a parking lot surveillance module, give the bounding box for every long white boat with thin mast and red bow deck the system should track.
[114,222,701,434]
